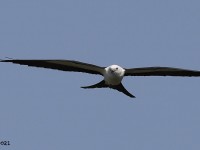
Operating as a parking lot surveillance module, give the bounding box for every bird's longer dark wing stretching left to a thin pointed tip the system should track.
[0,59,104,75]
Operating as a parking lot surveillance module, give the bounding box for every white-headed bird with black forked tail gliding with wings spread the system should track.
[0,59,200,98]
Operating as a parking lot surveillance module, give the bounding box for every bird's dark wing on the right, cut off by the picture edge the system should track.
[125,67,200,77]
